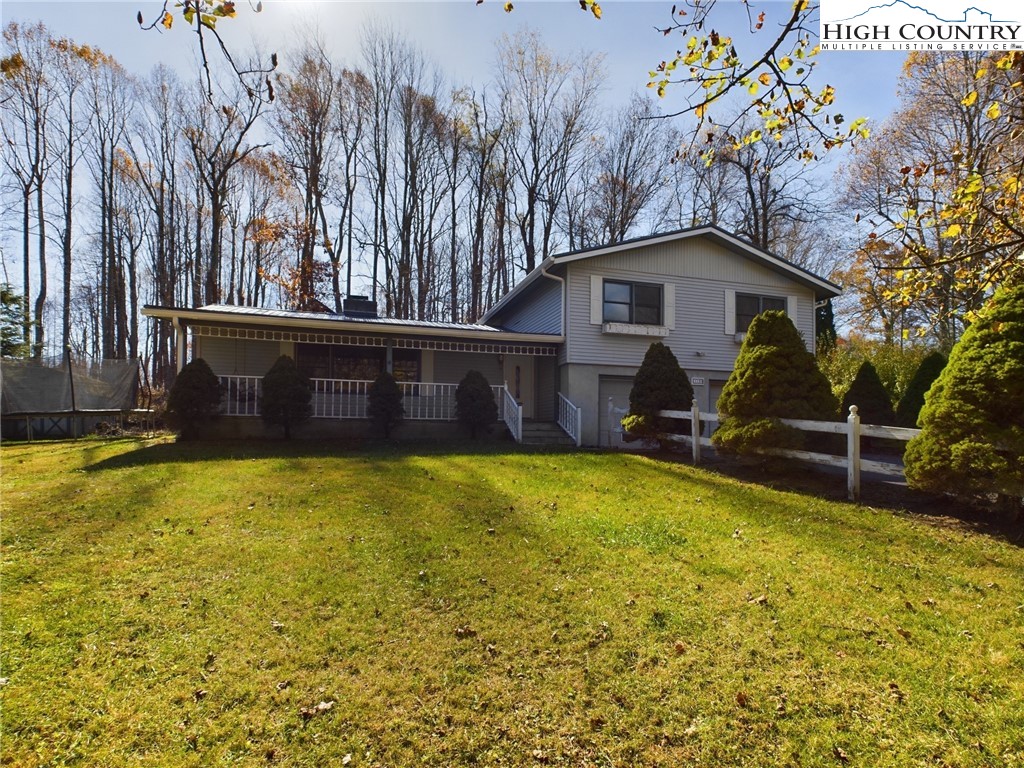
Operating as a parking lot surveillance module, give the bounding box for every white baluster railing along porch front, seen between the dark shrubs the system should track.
[220,376,507,434]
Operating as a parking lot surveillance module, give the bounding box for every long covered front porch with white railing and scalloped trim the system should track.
[143,306,580,444]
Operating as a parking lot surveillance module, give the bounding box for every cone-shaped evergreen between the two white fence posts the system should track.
[712,310,837,454]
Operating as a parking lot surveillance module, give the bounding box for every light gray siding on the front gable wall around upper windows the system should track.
[565,239,814,372]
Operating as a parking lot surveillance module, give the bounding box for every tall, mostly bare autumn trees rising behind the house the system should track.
[6,24,1015,391]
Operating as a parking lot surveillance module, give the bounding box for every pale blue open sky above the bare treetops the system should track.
[0,0,904,138]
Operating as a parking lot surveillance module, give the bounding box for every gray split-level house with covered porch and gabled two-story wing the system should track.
[143,226,840,445]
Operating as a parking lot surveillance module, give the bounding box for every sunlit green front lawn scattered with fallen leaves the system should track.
[0,439,1024,766]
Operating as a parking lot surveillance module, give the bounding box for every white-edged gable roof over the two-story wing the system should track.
[480,224,842,323]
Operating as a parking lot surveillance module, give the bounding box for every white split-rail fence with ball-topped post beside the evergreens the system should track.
[658,400,921,501]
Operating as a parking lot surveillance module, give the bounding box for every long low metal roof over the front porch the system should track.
[142,304,564,344]
